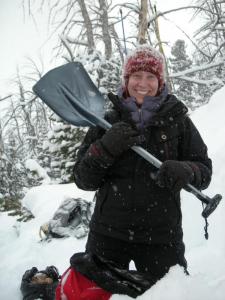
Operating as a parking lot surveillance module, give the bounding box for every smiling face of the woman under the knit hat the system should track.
[127,71,159,105]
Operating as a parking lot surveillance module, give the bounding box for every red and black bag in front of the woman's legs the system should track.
[56,253,156,300]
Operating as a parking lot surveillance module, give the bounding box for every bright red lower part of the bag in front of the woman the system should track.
[55,268,112,300]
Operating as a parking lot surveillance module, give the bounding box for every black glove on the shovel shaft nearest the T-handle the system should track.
[156,160,194,192]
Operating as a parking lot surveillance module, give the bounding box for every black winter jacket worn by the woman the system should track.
[74,94,212,243]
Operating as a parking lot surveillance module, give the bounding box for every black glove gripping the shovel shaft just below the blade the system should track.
[100,122,139,157]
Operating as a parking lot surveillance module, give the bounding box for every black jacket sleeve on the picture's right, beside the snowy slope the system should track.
[179,116,212,190]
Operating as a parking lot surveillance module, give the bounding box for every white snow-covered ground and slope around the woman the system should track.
[0,88,225,300]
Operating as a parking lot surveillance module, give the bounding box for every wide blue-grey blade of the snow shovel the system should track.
[33,62,105,126]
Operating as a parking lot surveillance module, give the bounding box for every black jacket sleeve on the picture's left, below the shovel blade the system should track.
[73,127,114,191]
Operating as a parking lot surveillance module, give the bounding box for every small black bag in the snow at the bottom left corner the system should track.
[20,266,60,300]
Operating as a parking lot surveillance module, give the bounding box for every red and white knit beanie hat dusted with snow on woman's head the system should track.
[123,44,165,90]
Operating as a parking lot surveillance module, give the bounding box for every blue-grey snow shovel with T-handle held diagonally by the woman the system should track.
[33,62,222,218]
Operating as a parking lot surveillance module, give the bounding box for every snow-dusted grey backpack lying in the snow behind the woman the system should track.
[40,198,93,238]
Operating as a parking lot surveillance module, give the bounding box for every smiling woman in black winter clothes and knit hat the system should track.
[74,45,212,280]
